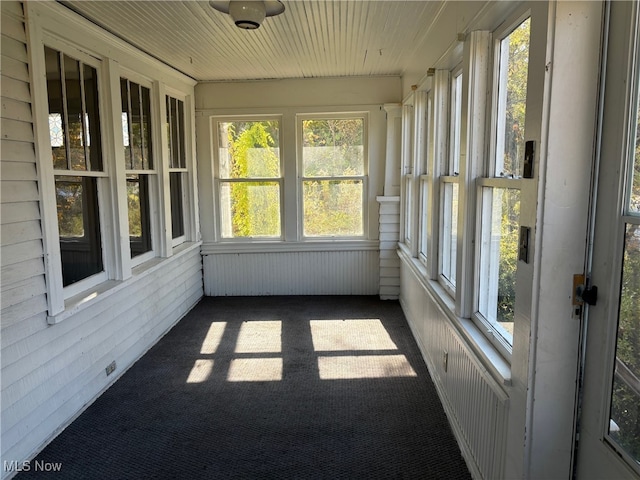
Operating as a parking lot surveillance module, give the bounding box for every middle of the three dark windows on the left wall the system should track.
[120,78,156,258]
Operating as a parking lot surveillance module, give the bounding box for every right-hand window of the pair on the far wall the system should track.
[300,117,367,237]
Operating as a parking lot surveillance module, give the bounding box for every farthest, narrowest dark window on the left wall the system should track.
[166,95,188,241]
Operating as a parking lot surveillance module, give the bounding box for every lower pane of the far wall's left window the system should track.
[220,182,281,238]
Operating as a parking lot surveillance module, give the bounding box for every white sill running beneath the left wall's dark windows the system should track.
[47,242,201,325]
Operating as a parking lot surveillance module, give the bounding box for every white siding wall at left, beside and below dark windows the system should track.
[0,1,203,478]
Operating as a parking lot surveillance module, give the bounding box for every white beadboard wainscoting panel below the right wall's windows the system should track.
[400,254,509,479]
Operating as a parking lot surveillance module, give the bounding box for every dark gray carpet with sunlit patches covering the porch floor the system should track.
[17,297,470,480]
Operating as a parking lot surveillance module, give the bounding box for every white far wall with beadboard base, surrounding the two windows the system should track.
[195,77,401,295]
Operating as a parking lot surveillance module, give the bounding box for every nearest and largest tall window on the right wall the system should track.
[476,18,530,350]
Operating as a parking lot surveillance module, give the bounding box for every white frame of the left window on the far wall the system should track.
[210,114,286,243]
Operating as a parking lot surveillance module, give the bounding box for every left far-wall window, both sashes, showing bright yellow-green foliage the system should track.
[216,119,282,239]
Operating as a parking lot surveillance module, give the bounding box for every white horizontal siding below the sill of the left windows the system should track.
[1,248,203,470]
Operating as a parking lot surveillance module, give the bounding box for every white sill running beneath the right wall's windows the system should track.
[398,244,511,386]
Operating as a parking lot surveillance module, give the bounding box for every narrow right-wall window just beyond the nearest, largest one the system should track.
[439,71,462,291]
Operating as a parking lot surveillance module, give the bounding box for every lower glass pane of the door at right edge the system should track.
[609,225,640,461]
